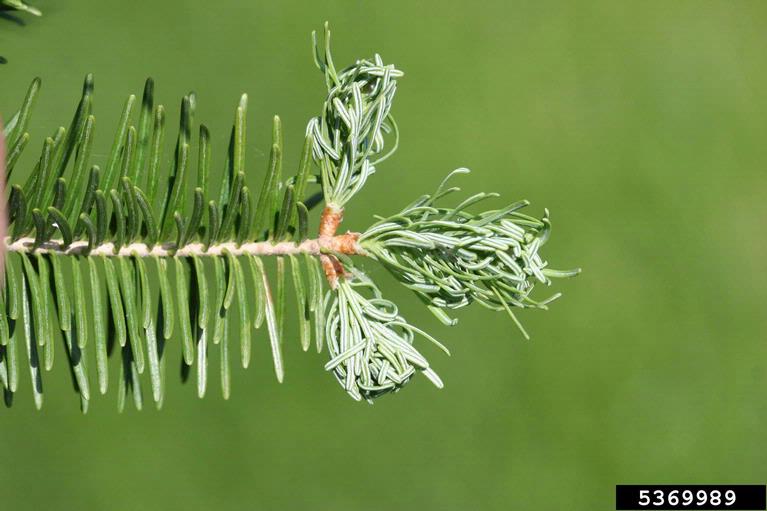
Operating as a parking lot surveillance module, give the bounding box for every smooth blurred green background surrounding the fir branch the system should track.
[0,0,767,510]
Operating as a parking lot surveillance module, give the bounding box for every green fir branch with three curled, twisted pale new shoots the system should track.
[0,24,578,411]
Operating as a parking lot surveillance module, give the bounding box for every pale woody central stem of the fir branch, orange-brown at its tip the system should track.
[2,232,366,257]
